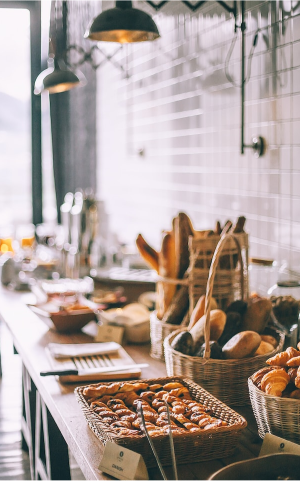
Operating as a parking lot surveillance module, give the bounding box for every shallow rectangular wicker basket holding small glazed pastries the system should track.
[75,376,247,467]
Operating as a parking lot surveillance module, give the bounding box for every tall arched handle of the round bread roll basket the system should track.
[203,233,244,359]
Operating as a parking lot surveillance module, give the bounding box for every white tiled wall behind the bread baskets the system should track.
[97,0,300,272]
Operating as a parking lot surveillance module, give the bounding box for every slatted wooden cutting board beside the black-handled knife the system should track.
[45,347,141,383]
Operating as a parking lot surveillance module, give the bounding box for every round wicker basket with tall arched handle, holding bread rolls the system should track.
[164,234,284,406]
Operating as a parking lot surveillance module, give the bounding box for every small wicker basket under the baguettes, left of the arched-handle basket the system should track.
[150,311,178,361]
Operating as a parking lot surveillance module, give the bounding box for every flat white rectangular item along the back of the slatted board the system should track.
[48,342,121,359]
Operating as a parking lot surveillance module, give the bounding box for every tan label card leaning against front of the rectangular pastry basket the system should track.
[99,441,149,481]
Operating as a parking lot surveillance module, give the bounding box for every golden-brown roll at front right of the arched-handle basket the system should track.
[222,331,261,359]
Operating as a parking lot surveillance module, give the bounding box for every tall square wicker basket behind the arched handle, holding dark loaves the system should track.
[189,232,249,313]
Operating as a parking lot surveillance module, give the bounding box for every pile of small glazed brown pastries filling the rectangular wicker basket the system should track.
[85,380,229,437]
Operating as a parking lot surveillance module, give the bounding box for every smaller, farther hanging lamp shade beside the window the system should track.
[34,58,86,95]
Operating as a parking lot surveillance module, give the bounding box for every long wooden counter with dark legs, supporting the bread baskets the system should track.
[0,288,261,481]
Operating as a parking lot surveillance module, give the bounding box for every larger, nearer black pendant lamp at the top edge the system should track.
[85,0,160,43]
